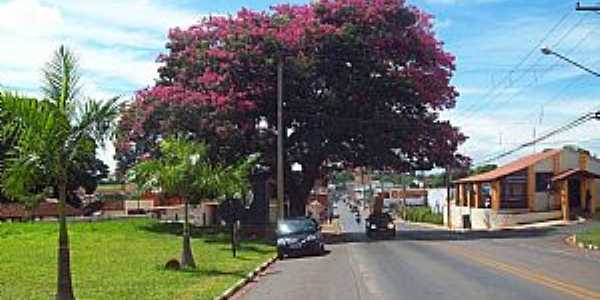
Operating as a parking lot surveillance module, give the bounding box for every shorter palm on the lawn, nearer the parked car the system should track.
[129,137,223,268]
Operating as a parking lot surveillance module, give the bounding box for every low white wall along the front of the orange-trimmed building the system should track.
[444,205,562,229]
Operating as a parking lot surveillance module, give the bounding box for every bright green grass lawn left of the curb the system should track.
[0,219,275,300]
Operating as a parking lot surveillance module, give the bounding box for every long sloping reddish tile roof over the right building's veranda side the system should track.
[454,149,561,183]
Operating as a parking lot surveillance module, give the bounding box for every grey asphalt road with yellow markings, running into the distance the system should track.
[235,203,600,300]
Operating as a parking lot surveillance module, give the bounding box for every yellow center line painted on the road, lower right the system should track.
[445,245,600,300]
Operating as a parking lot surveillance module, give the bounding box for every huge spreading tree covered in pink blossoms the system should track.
[117,0,465,214]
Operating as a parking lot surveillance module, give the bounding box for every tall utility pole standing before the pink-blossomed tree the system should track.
[277,57,287,220]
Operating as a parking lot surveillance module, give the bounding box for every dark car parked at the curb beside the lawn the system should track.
[277,217,325,259]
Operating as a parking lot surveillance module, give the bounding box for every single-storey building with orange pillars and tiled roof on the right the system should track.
[444,147,600,229]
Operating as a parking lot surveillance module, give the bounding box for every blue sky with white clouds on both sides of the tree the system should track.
[0,0,600,169]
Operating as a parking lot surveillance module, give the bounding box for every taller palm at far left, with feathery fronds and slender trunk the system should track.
[0,46,119,300]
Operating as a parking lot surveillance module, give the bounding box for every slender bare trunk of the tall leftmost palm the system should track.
[56,178,75,300]
